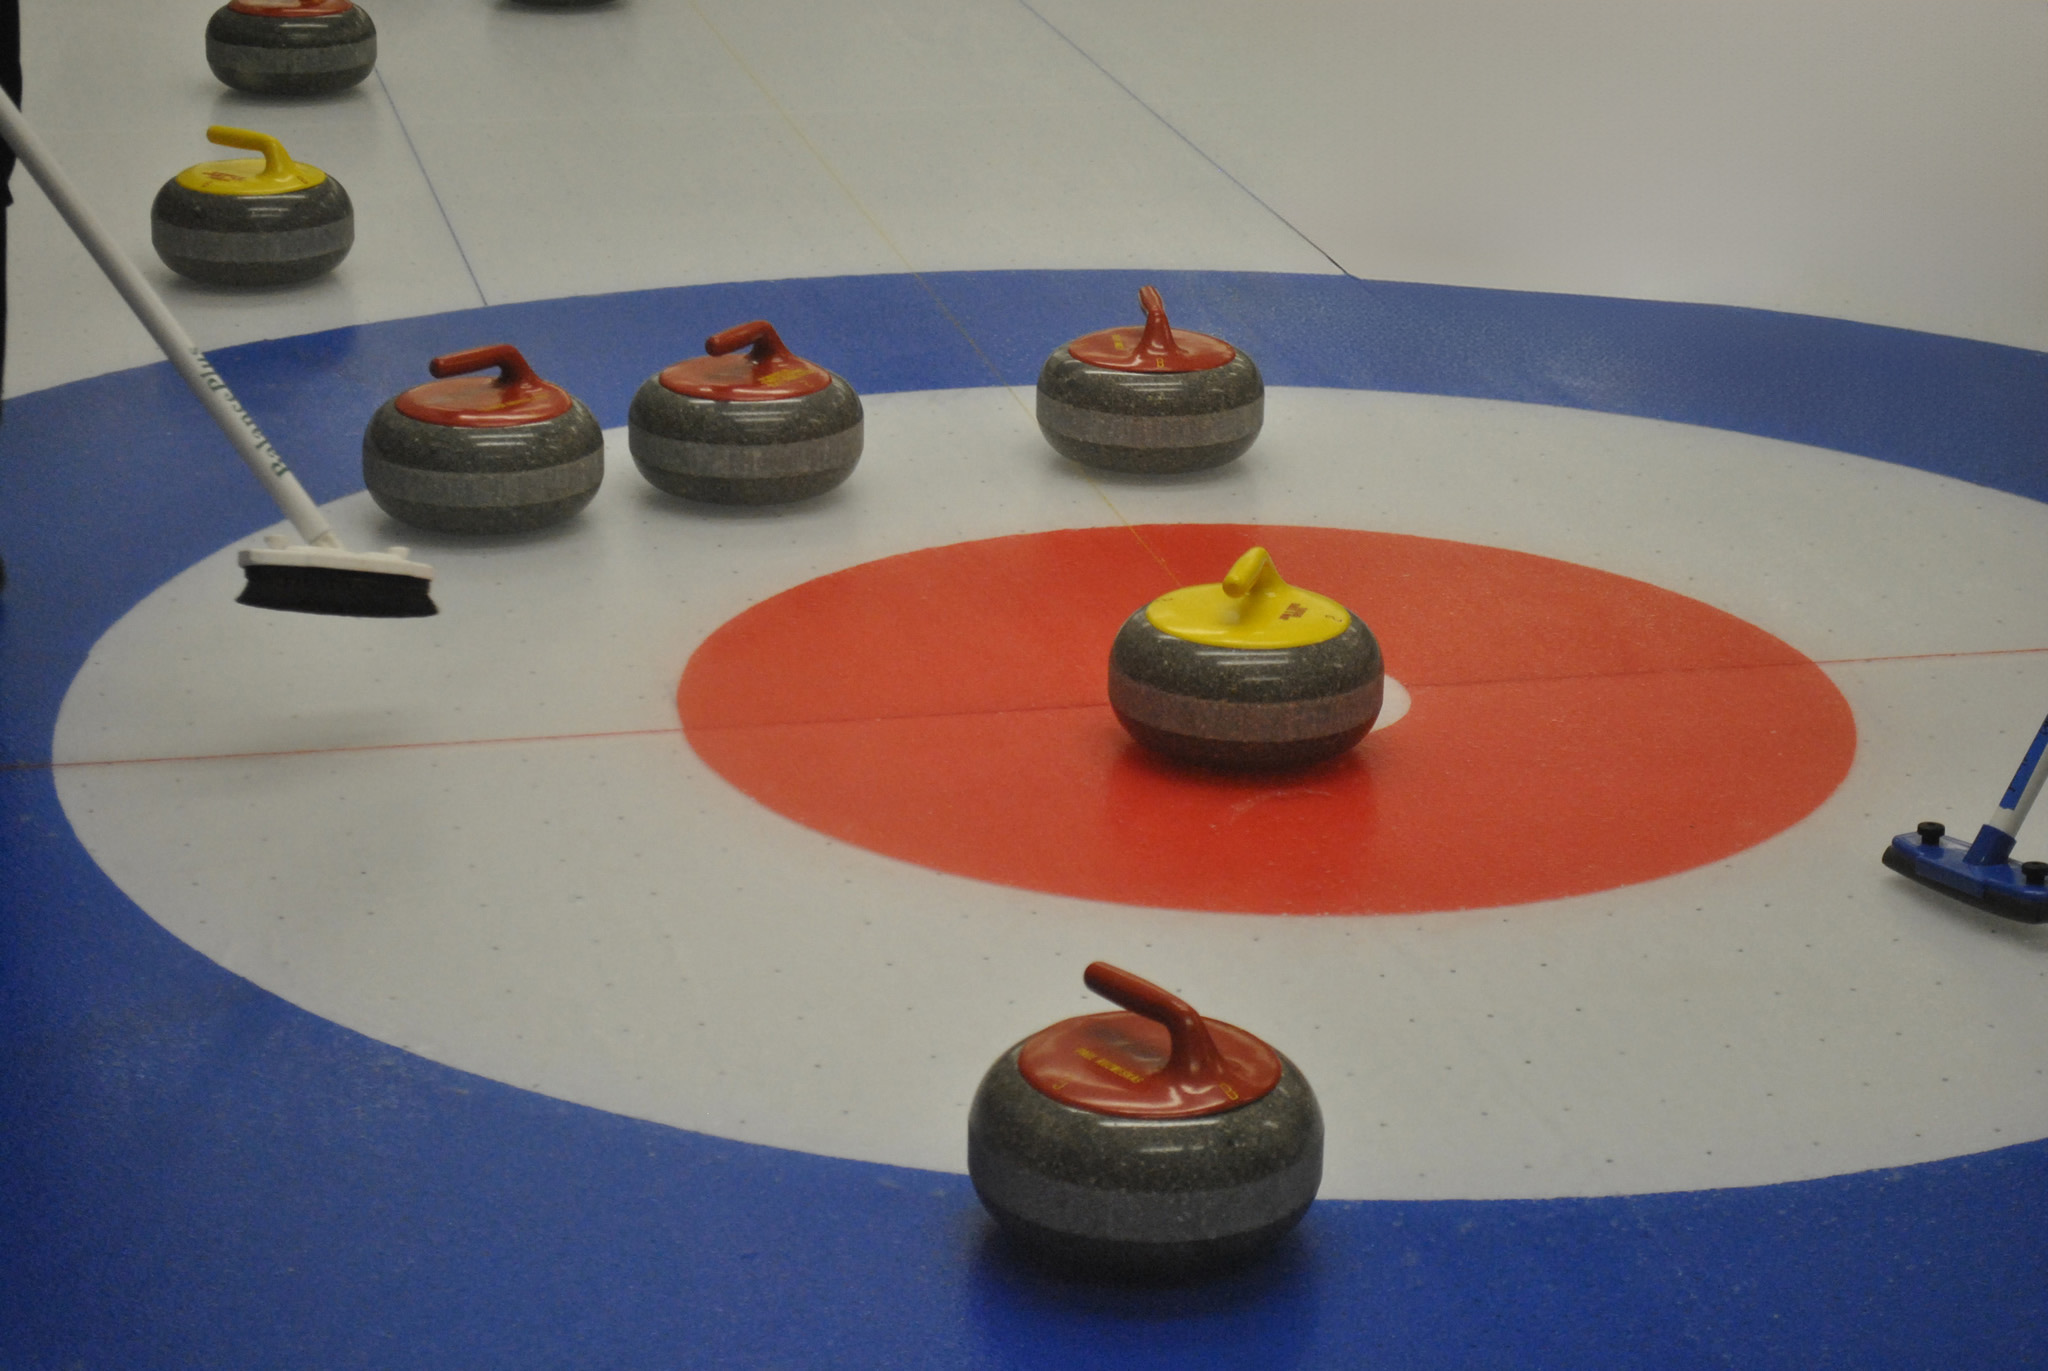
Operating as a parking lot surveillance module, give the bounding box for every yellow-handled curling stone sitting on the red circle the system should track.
[1110,547,1386,771]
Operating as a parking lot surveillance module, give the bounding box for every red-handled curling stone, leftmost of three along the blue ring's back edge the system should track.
[362,344,604,533]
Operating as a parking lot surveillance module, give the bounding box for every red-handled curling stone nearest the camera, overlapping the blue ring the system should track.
[967,961,1323,1279]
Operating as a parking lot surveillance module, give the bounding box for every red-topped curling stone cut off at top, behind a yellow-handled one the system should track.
[207,0,377,94]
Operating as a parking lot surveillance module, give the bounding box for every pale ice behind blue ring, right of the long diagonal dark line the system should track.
[1026,0,2048,348]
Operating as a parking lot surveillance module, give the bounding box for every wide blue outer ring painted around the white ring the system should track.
[0,273,2048,1371]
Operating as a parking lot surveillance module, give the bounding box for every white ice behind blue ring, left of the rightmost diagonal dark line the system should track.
[6,0,1333,393]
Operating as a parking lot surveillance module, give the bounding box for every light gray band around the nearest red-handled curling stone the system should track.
[975,1154,1323,1242]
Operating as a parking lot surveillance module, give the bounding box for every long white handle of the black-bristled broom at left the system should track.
[0,92,340,547]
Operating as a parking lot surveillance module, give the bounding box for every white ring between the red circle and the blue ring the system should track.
[55,389,2048,1197]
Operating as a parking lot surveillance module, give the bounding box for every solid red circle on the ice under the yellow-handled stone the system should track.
[678,525,1855,914]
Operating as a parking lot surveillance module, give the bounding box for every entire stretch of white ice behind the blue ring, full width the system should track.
[6,0,2048,393]
